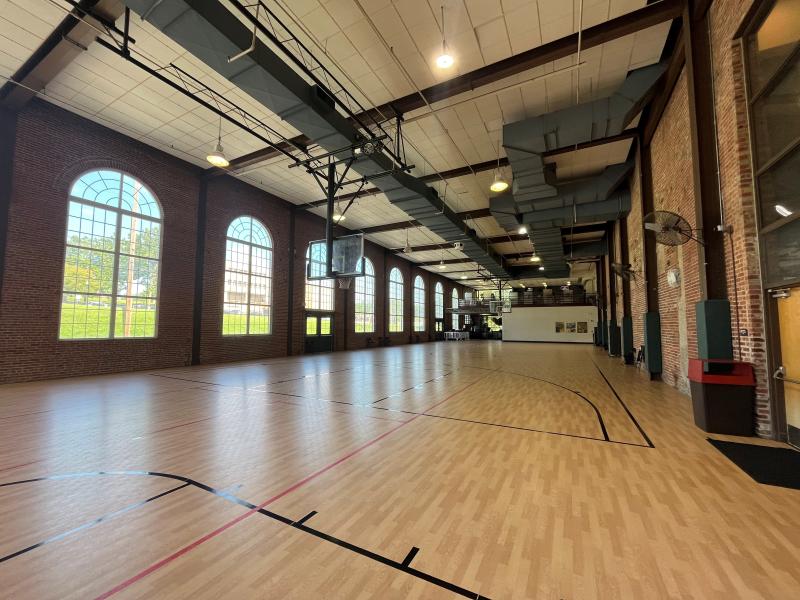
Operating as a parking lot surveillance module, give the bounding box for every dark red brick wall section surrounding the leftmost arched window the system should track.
[0,101,199,382]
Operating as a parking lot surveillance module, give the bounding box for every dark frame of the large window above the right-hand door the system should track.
[737,0,800,289]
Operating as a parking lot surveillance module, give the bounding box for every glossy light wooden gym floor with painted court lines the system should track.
[0,341,800,600]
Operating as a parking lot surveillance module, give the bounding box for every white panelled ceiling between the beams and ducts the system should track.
[0,0,669,286]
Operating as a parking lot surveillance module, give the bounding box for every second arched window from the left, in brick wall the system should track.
[222,216,272,335]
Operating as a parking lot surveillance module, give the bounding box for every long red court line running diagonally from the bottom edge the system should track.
[95,377,484,600]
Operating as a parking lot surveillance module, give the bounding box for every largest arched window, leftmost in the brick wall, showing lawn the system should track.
[58,170,162,340]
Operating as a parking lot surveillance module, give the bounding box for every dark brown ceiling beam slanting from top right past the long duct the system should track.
[216,0,683,172]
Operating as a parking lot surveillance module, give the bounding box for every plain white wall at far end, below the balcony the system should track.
[503,306,597,343]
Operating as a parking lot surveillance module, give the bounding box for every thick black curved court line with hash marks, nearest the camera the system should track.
[0,471,489,600]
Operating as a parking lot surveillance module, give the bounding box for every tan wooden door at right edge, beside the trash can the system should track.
[773,288,800,447]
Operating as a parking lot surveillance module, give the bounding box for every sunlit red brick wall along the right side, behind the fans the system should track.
[628,0,776,437]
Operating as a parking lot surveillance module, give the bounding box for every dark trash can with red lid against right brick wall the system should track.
[689,358,756,435]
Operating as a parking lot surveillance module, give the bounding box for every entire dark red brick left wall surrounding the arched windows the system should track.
[0,101,472,383]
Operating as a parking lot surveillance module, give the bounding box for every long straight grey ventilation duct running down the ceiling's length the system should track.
[125,0,509,277]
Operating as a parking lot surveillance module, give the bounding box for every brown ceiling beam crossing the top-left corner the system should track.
[0,0,125,110]
